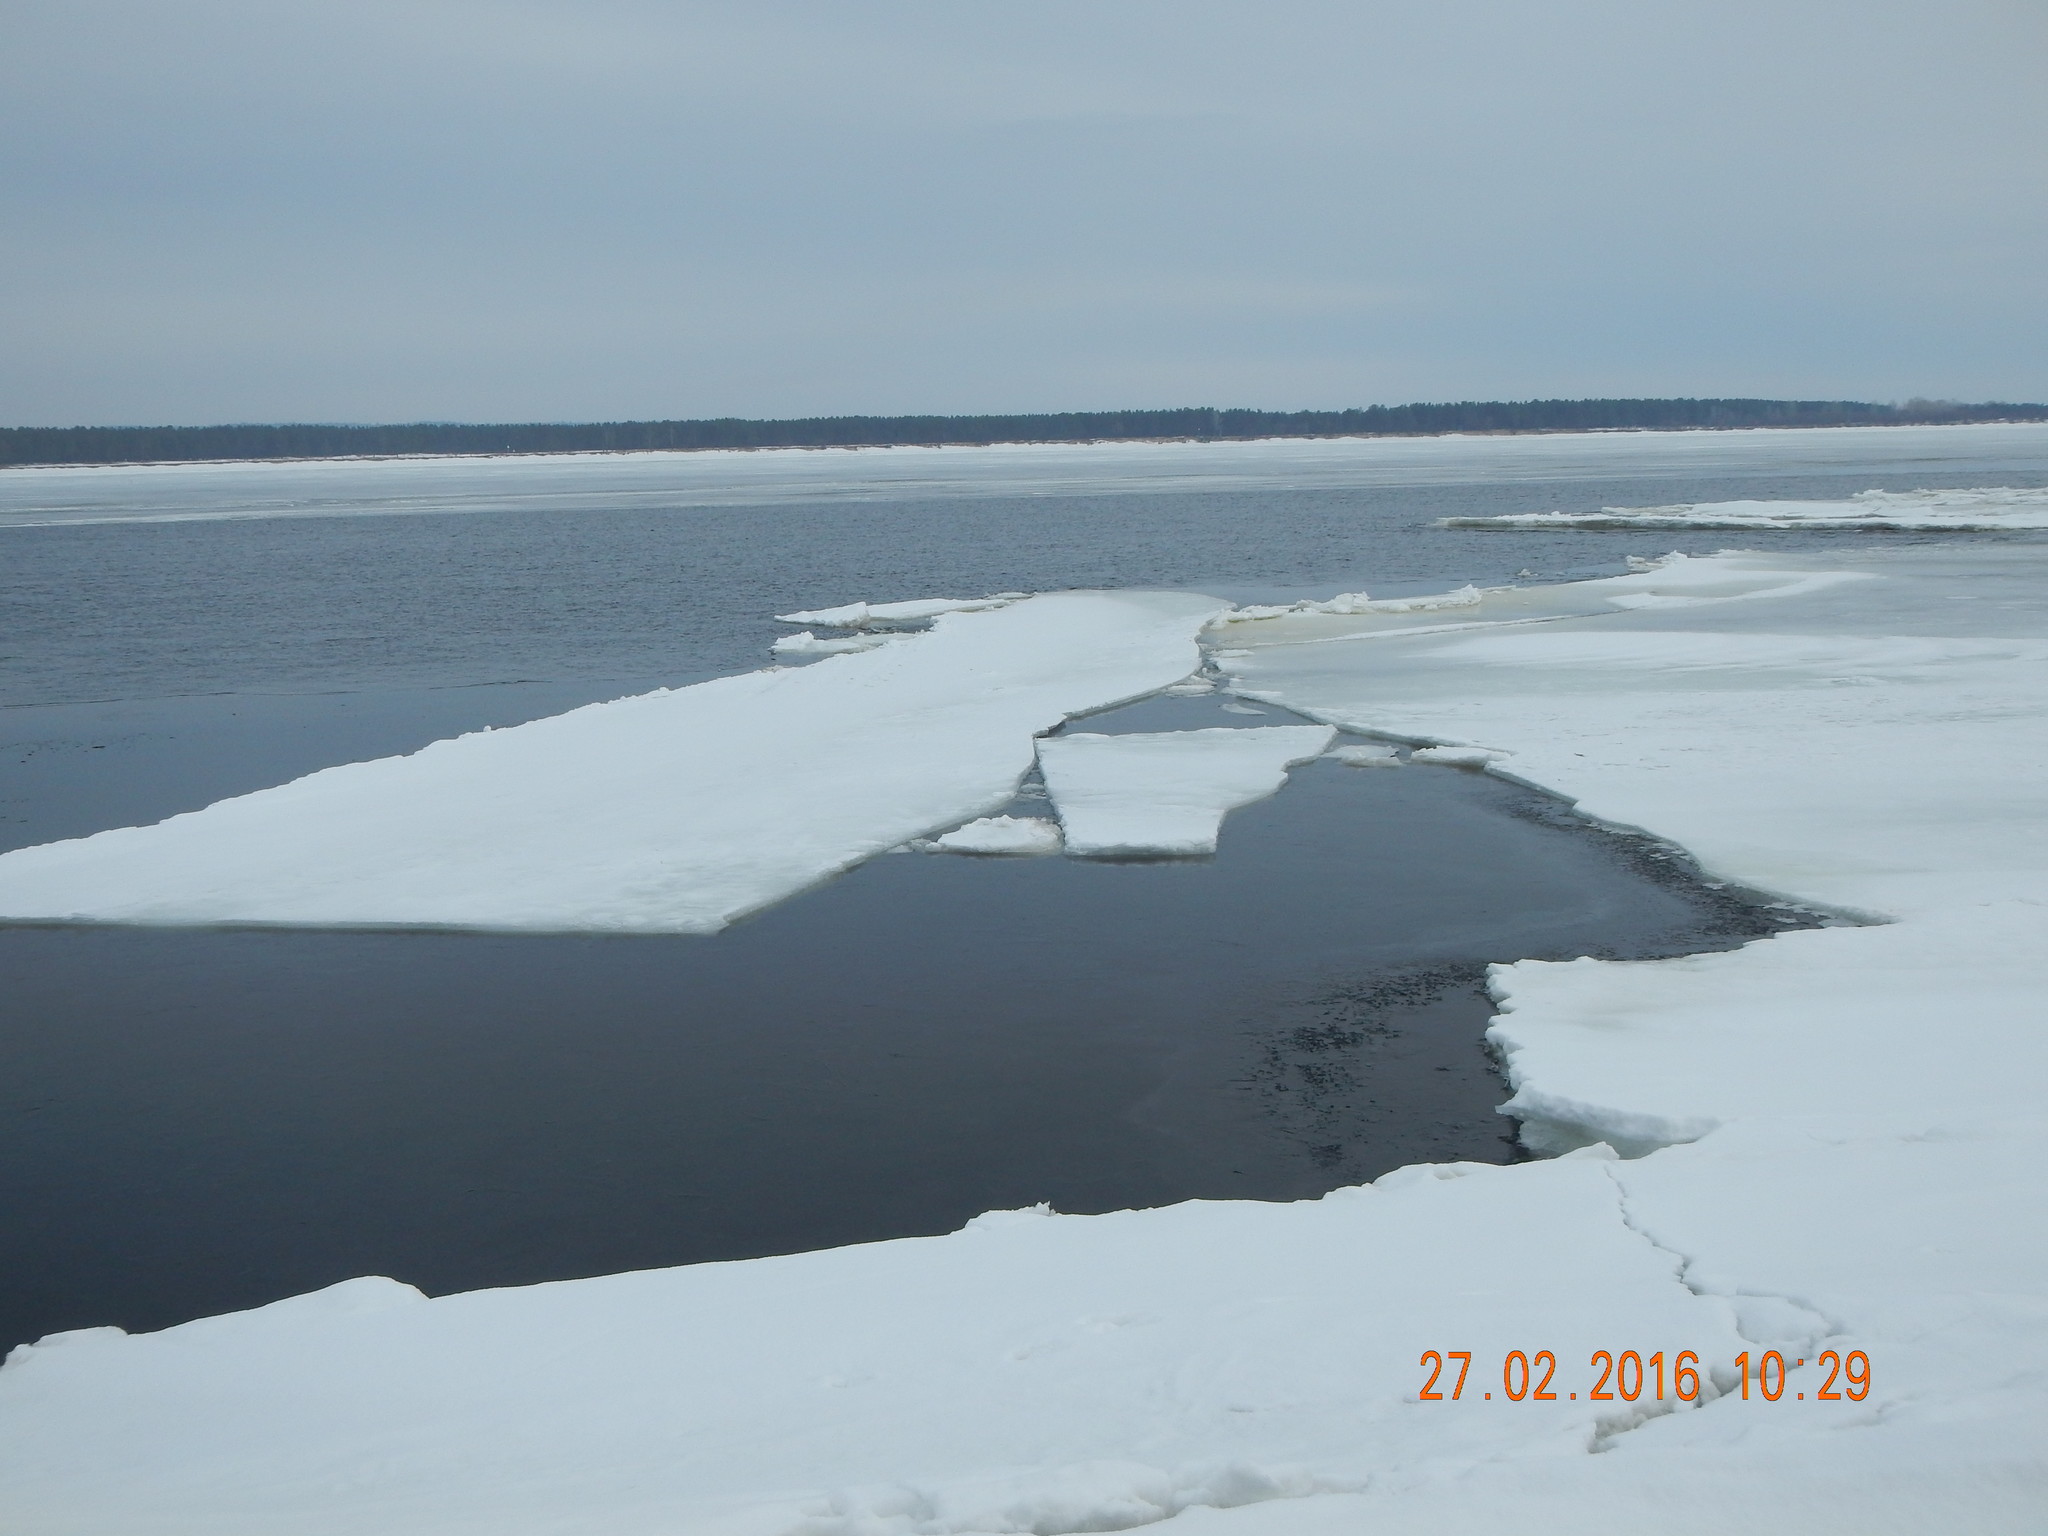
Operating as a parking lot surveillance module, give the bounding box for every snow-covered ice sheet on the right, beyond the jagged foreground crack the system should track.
[1204,547,2048,1532]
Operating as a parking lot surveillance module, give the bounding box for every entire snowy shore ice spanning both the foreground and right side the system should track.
[0,545,2048,1536]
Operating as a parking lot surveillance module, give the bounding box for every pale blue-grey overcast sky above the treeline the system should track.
[0,0,2048,424]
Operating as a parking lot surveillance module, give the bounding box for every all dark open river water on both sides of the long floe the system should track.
[0,430,2048,1346]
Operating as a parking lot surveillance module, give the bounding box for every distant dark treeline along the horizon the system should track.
[0,399,2048,465]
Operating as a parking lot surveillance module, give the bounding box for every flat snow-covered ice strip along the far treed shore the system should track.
[12,422,2042,526]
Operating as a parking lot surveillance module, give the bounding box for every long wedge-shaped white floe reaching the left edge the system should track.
[0,592,1221,932]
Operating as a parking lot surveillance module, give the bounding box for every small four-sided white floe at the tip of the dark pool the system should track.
[1038,725,1335,858]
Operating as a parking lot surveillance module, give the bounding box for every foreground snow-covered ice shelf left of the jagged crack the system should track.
[0,1155,1741,1536]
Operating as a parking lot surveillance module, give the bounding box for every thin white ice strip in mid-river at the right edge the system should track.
[1438,485,2048,532]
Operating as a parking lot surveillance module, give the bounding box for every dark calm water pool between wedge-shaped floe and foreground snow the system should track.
[0,753,1810,1341]
